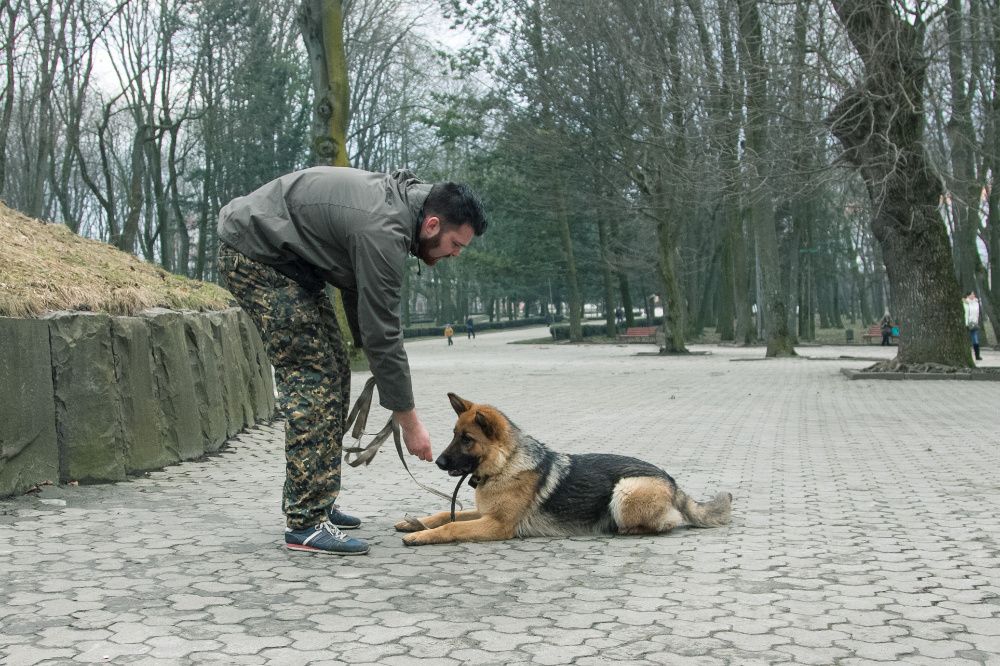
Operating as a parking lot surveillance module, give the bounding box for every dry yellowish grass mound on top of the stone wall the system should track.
[0,203,233,317]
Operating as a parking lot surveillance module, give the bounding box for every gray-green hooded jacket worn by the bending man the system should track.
[219,167,431,411]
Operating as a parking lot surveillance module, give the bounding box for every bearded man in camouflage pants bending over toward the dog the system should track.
[219,167,486,555]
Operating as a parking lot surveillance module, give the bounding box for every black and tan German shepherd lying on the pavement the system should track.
[396,393,733,546]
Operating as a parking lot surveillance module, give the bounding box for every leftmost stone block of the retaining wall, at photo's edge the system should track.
[0,317,59,497]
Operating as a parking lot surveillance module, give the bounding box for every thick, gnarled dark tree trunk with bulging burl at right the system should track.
[828,0,972,367]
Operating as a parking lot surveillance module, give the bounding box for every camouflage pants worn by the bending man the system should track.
[219,243,351,529]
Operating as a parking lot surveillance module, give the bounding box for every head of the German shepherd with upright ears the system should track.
[435,393,512,476]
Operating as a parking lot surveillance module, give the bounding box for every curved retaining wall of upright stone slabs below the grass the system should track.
[0,308,275,497]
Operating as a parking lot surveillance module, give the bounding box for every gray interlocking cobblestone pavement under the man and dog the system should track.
[0,329,1000,666]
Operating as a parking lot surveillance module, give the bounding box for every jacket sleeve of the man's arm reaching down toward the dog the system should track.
[345,227,413,411]
